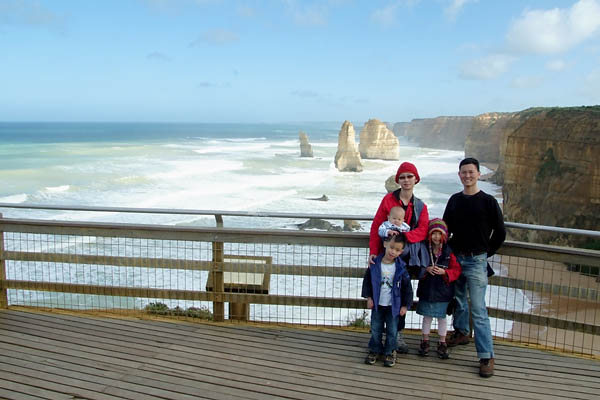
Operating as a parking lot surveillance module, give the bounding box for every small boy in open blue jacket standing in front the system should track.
[362,233,413,367]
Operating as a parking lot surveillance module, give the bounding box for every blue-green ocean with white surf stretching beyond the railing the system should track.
[0,122,528,332]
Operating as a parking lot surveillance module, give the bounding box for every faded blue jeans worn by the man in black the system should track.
[453,253,494,359]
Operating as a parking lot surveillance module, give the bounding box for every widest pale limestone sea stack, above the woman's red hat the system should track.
[358,119,400,160]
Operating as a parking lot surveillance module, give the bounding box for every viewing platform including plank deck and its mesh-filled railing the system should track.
[0,204,600,399]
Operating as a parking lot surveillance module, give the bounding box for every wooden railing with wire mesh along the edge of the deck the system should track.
[0,205,600,356]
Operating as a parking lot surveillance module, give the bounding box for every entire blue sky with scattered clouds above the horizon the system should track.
[0,0,600,123]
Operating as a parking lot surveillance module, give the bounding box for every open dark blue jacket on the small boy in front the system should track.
[361,253,413,317]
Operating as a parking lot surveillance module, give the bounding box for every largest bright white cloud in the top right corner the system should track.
[506,0,600,54]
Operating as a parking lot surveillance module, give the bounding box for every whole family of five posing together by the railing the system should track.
[362,158,506,378]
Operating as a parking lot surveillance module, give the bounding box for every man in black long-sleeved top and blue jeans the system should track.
[444,158,506,378]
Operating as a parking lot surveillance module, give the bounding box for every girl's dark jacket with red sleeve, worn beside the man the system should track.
[417,243,461,303]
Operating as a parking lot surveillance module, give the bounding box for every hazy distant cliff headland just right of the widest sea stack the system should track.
[394,117,473,150]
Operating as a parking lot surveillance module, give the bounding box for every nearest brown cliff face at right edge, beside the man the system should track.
[502,106,600,243]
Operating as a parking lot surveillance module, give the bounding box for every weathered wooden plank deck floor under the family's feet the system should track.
[0,310,600,400]
